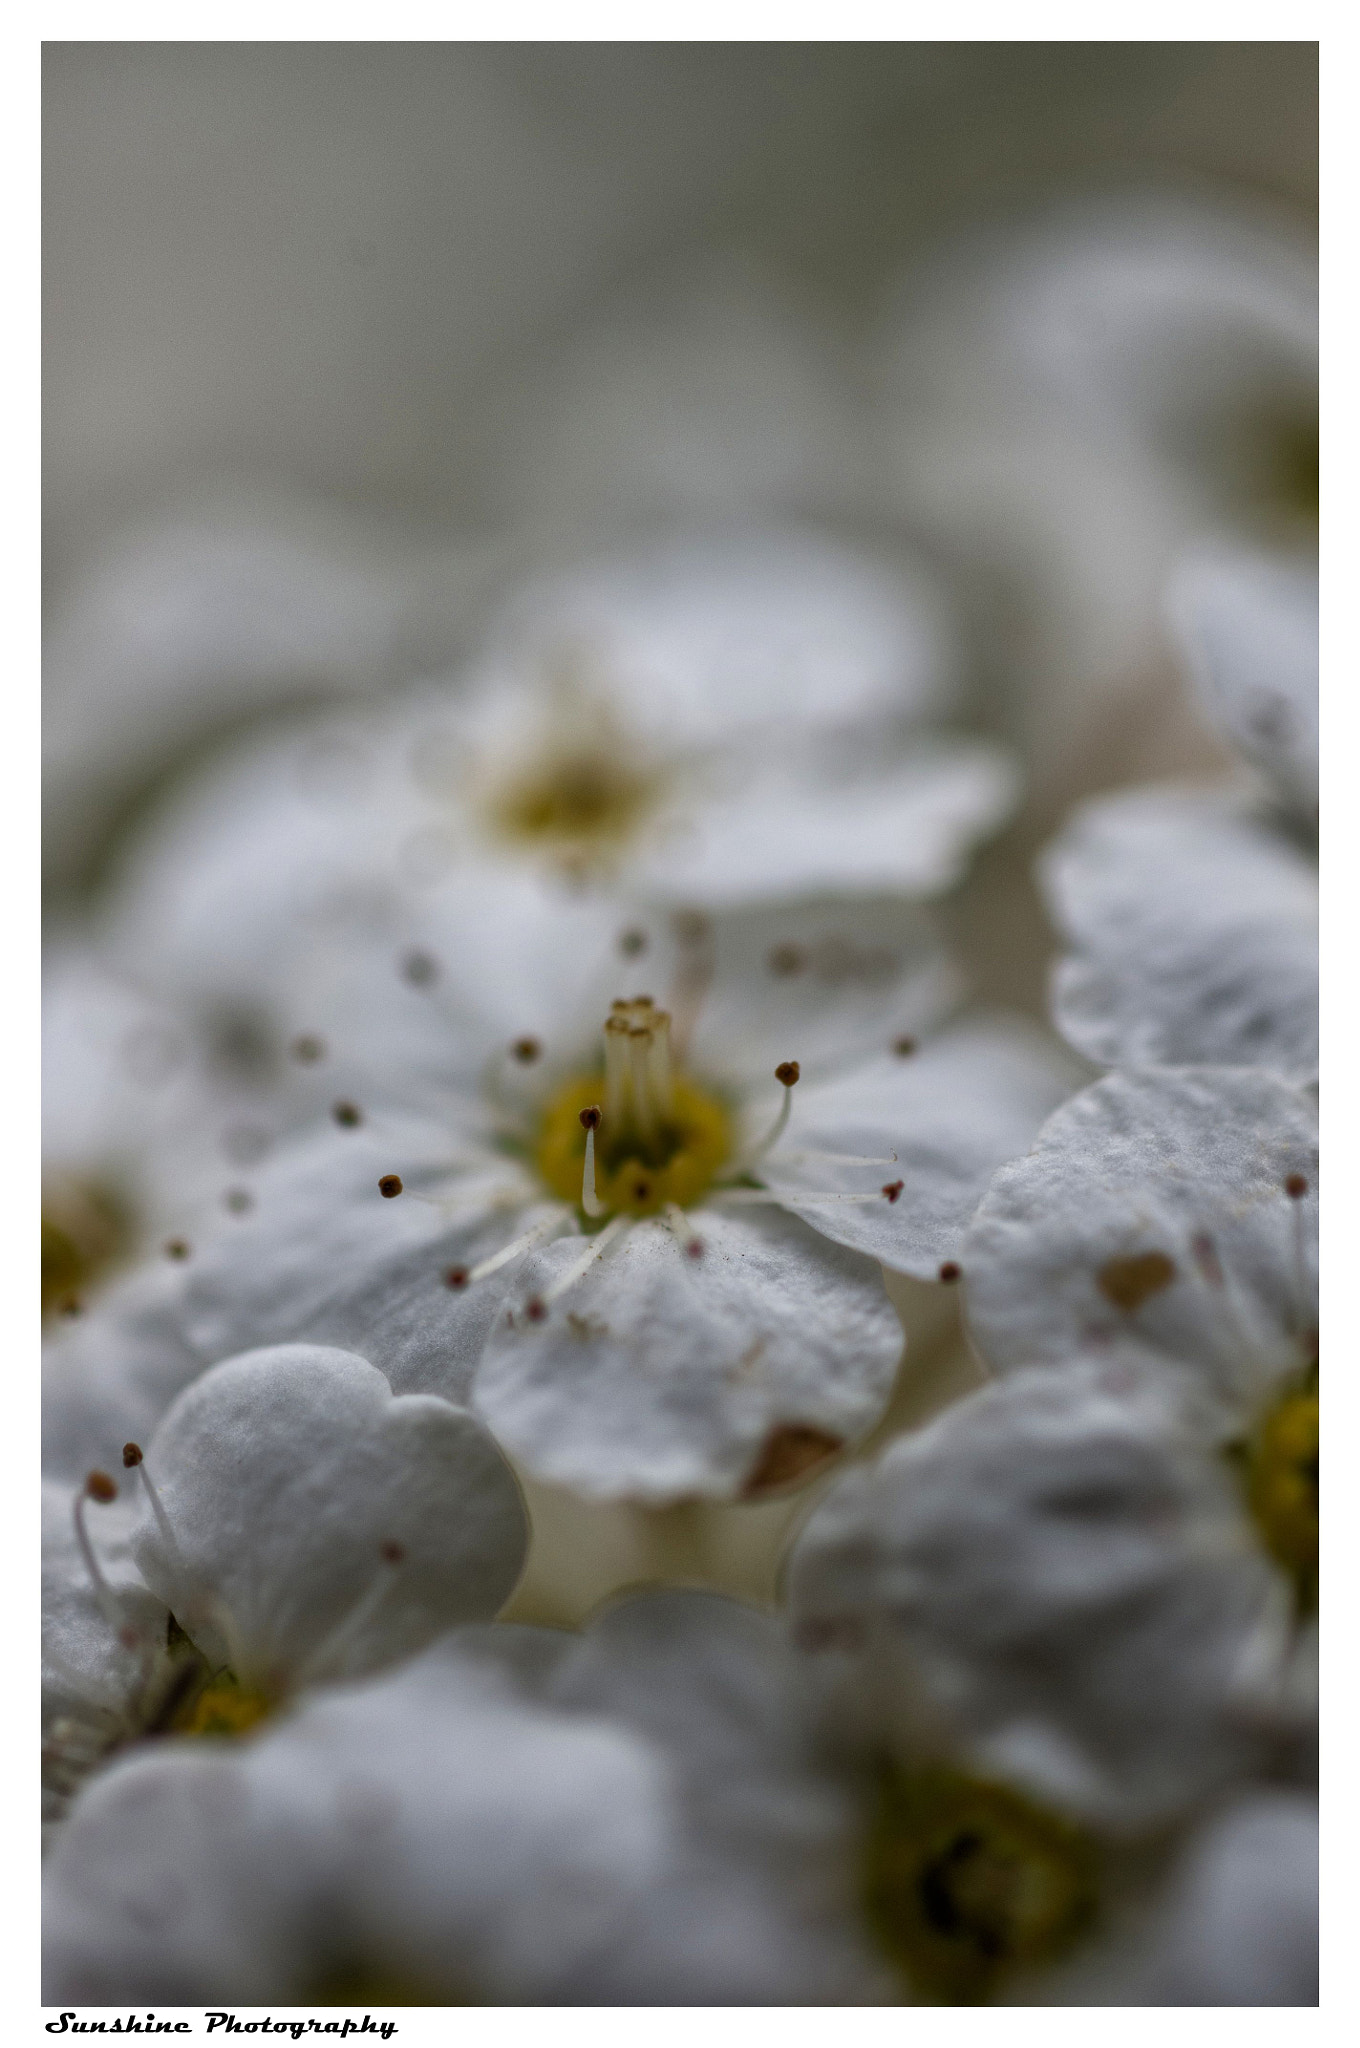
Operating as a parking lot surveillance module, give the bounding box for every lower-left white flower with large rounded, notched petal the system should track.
[45,1346,528,1826]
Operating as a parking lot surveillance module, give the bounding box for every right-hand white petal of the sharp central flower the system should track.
[756,1022,1075,1280]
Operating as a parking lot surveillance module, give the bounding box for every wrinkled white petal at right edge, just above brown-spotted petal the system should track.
[1043,791,1317,1081]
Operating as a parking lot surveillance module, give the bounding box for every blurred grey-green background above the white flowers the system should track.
[43,43,1317,1008]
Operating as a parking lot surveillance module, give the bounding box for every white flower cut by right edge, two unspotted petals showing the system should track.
[1040,551,1317,1081]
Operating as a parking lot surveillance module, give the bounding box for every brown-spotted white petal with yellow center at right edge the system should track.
[963,1067,1319,1630]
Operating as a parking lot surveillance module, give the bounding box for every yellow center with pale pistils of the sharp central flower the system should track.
[535,995,733,1217]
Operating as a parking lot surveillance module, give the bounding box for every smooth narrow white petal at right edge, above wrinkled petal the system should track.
[1170,551,1317,819]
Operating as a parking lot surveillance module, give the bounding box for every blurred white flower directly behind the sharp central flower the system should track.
[93,530,1014,1036]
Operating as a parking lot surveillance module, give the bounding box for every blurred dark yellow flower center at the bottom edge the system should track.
[864,1767,1096,2005]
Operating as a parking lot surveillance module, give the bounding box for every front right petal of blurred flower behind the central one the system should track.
[637,739,1016,905]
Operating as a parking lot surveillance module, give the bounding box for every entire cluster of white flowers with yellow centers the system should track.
[43,209,1319,2005]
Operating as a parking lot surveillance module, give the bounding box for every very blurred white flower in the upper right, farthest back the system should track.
[881,193,1317,795]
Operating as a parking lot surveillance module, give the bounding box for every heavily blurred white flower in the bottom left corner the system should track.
[43,1638,672,2005]
